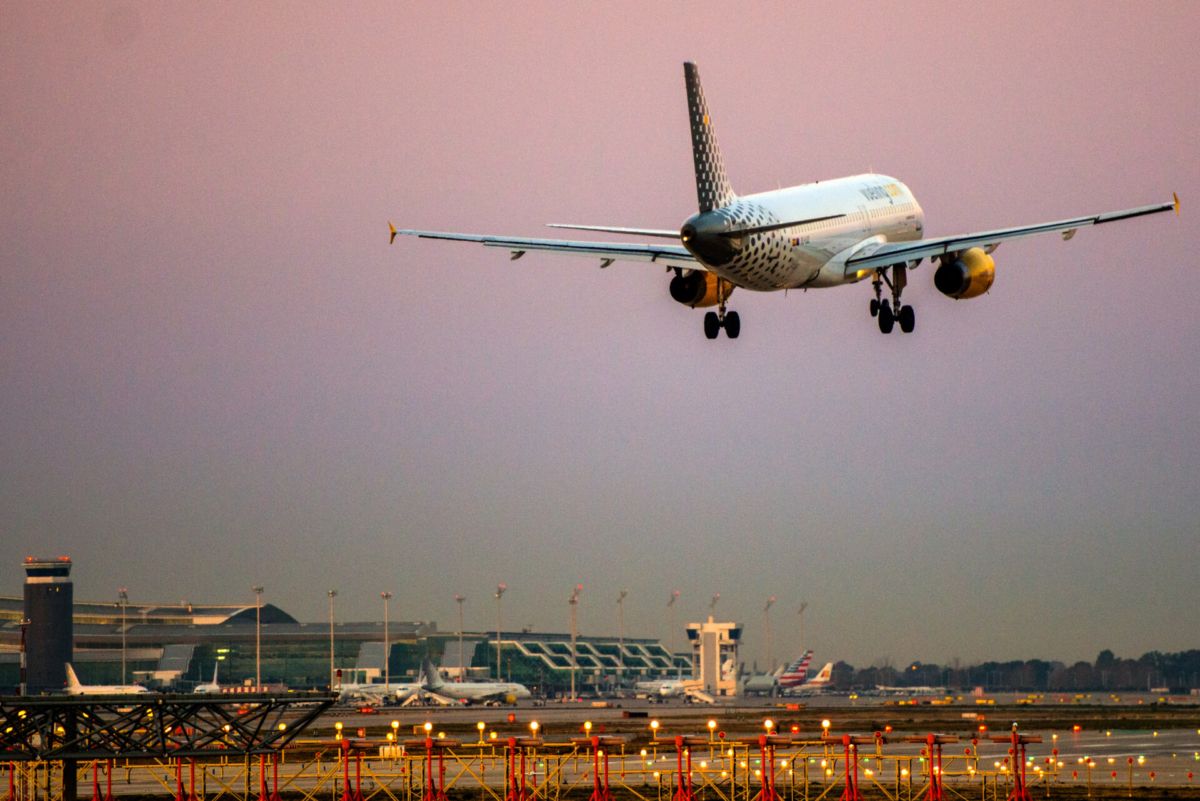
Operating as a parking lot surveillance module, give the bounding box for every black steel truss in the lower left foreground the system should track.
[0,693,335,761]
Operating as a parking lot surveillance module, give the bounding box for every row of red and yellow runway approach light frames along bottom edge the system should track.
[0,733,1196,801]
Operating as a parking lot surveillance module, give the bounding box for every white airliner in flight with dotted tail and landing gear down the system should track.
[388,62,1180,339]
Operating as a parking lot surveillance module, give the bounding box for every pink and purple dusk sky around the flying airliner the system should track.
[0,2,1200,666]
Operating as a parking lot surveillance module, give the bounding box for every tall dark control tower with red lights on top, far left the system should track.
[25,556,74,695]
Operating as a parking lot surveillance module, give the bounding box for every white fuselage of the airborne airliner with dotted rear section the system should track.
[685,174,925,291]
